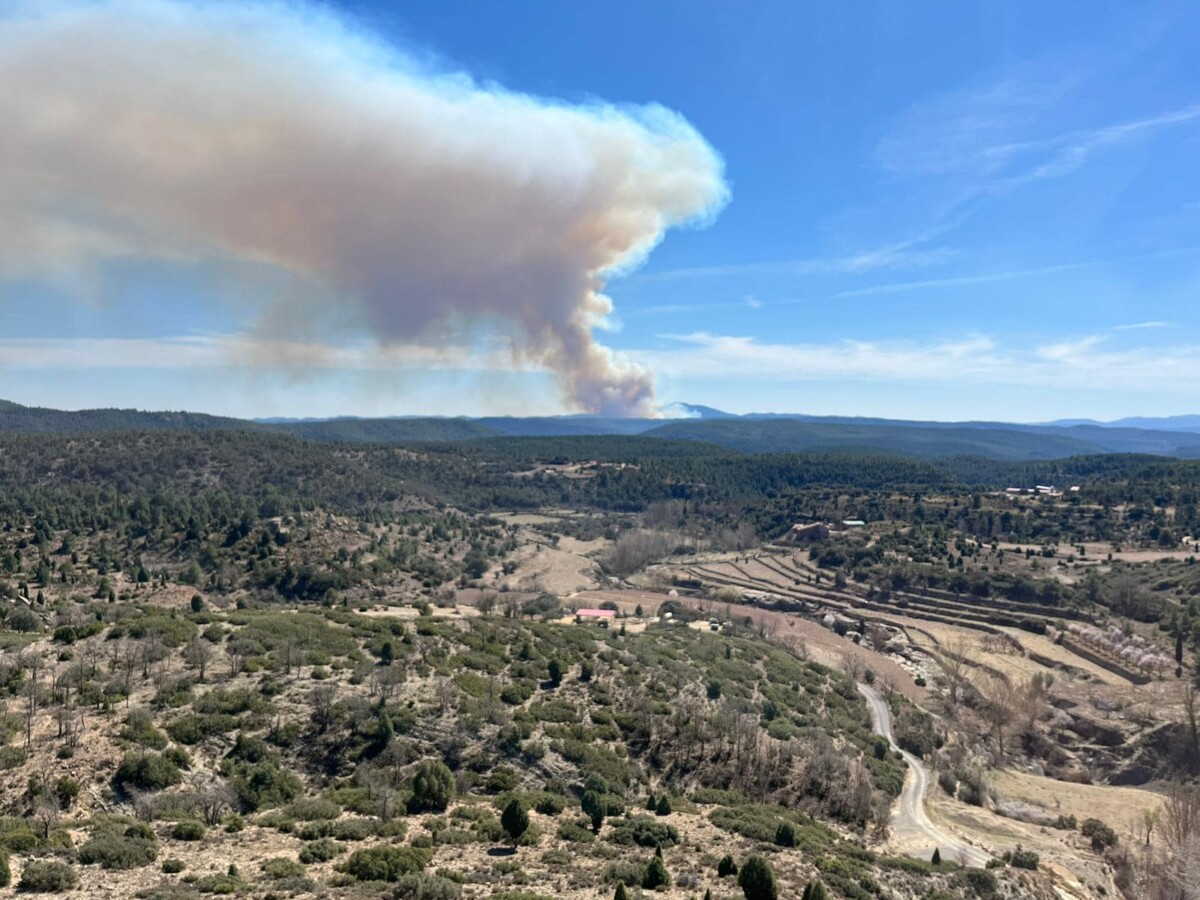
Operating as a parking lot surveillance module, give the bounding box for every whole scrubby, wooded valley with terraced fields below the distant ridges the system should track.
[0,432,1200,900]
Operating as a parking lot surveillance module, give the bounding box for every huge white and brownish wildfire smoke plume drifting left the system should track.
[0,0,727,414]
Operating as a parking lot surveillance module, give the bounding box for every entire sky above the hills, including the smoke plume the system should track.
[0,0,1200,421]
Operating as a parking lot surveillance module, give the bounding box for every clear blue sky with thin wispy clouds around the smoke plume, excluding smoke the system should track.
[0,0,1200,421]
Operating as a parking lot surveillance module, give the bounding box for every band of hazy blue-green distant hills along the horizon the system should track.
[0,401,1200,461]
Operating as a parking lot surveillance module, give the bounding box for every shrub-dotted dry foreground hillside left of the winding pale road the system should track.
[0,592,1060,898]
